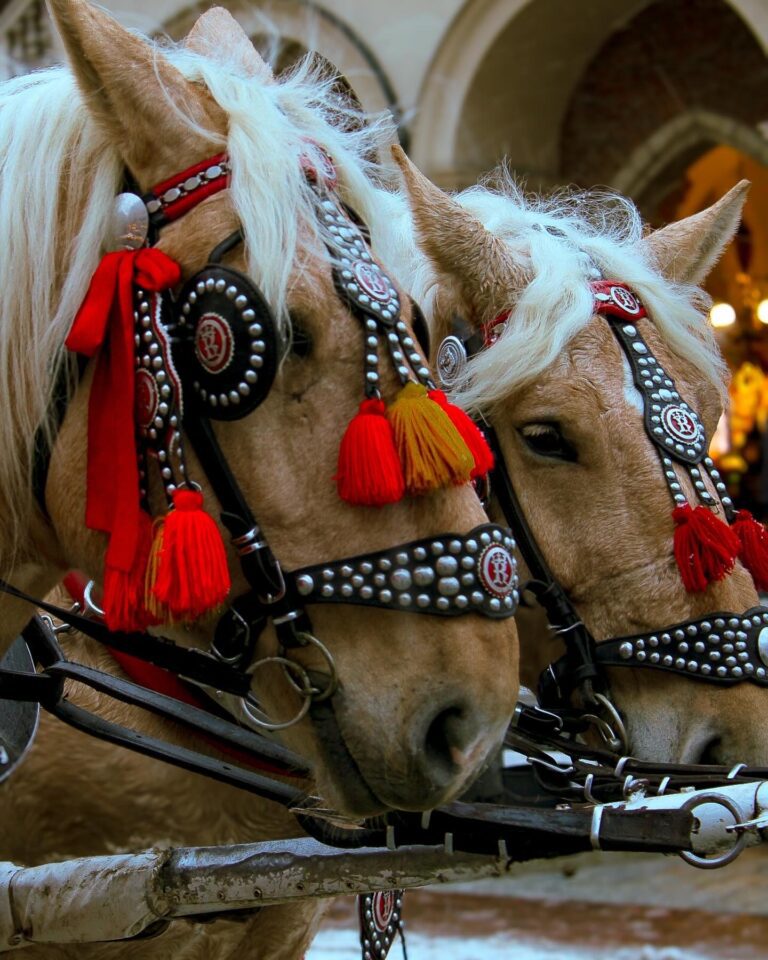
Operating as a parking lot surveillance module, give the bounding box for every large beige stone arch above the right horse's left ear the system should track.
[413,0,650,186]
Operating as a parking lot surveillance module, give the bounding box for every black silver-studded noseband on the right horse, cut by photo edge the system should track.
[595,607,768,687]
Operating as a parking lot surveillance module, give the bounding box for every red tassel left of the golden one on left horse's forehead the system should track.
[335,399,405,507]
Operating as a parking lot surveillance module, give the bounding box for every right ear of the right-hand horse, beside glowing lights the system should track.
[640,180,750,285]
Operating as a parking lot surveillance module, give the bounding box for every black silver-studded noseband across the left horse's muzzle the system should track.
[292,524,520,619]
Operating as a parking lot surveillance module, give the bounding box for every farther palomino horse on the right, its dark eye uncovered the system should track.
[384,156,768,763]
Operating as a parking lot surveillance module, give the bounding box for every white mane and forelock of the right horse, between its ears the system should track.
[374,172,726,414]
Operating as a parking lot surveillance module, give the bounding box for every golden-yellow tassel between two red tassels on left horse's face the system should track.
[387,383,475,494]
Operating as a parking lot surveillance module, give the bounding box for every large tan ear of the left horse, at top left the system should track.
[48,0,226,187]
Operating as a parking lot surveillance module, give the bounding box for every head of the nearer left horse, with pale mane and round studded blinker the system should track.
[0,0,517,815]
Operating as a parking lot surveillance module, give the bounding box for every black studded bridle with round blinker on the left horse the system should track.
[0,143,519,730]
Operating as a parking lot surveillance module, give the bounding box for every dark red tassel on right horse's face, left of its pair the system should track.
[672,503,740,593]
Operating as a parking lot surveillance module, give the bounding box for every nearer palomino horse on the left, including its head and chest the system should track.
[0,0,517,958]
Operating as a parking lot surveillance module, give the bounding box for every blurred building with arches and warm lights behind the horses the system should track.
[0,0,768,512]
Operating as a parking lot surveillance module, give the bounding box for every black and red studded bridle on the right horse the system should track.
[437,281,768,752]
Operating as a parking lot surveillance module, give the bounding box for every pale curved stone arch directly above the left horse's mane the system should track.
[163,0,400,121]
